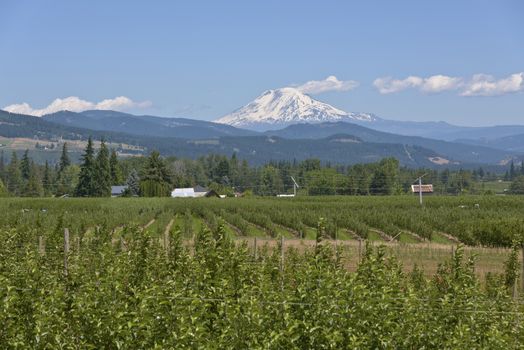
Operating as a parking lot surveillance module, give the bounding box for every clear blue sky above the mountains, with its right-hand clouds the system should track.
[0,0,524,125]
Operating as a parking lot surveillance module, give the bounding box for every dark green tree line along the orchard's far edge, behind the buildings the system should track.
[0,138,524,197]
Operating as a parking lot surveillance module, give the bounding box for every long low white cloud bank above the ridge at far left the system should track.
[3,96,151,117]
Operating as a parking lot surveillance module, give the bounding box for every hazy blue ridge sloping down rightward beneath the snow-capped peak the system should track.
[266,122,512,164]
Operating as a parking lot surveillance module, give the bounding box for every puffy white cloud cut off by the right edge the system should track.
[460,72,524,96]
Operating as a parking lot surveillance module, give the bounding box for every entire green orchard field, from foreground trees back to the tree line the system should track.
[0,196,524,349]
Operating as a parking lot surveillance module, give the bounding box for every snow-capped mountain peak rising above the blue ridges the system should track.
[216,87,378,130]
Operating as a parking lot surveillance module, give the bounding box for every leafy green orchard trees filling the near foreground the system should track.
[0,216,524,349]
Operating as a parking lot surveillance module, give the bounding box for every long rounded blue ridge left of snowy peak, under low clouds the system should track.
[42,110,256,139]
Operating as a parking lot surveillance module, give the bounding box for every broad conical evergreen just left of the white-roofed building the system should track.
[140,151,170,197]
